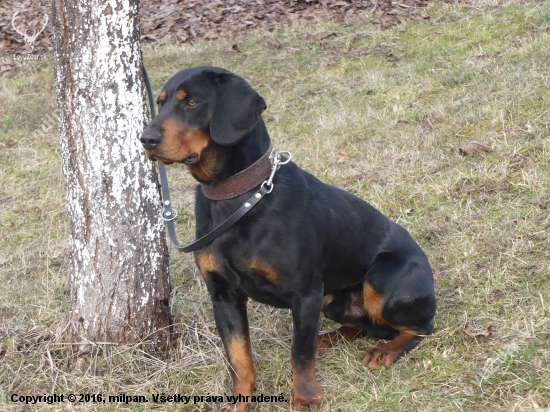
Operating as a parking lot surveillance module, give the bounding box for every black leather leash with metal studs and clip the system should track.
[142,65,291,253]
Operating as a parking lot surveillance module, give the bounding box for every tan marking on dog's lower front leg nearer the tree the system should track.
[227,337,256,396]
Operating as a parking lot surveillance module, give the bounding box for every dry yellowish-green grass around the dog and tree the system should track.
[0,2,550,412]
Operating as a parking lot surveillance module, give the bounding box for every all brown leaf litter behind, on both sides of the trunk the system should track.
[0,0,429,55]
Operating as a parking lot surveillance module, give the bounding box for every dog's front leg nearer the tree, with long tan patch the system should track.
[208,284,256,412]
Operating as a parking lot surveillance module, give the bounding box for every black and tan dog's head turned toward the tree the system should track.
[140,66,267,176]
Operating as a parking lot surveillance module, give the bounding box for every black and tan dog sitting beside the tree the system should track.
[141,67,435,411]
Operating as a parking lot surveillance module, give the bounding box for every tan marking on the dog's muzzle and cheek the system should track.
[161,119,212,162]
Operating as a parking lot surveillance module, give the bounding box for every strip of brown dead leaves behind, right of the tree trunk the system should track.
[140,0,429,46]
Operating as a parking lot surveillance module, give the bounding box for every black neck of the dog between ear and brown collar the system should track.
[209,117,271,185]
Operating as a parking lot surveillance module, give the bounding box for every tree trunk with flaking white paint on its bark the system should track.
[53,0,170,347]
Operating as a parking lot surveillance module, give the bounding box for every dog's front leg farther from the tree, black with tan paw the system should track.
[291,291,323,406]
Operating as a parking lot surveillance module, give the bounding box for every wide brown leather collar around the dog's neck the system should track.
[201,145,273,200]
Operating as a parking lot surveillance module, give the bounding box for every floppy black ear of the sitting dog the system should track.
[205,71,267,146]
